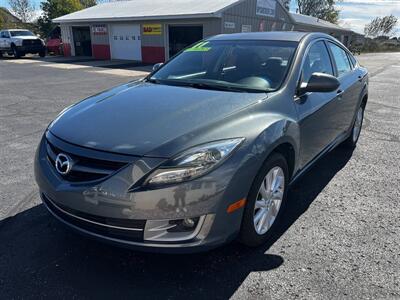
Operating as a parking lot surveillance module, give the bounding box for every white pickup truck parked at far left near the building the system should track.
[0,29,46,58]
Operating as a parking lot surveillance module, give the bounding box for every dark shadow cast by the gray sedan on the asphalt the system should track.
[0,148,352,299]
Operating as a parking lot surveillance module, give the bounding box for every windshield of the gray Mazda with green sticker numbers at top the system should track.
[152,40,298,92]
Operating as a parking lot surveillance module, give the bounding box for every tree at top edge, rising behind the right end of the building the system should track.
[297,0,341,24]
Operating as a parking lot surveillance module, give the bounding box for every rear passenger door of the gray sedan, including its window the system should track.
[328,42,363,132]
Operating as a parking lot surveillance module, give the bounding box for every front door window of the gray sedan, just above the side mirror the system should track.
[302,41,333,82]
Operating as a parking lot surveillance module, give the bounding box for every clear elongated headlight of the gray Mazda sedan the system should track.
[144,138,244,186]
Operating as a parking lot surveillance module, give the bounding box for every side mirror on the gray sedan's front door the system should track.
[299,73,340,95]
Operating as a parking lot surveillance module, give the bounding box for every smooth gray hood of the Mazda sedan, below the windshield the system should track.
[49,82,266,155]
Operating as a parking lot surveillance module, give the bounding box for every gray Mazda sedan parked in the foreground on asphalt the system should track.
[35,32,368,252]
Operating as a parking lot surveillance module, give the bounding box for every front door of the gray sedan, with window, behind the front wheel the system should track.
[295,39,341,167]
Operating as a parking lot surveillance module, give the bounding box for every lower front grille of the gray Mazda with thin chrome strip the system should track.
[42,194,146,242]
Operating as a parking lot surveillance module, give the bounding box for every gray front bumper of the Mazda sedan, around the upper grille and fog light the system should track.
[35,133,250,252]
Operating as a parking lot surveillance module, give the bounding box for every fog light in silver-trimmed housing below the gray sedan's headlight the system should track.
[144,216,205,242]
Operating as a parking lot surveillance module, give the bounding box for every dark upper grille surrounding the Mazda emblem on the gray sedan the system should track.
[46,140,128,182]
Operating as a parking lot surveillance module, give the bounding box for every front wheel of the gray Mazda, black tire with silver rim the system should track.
[239,153,289,247]
